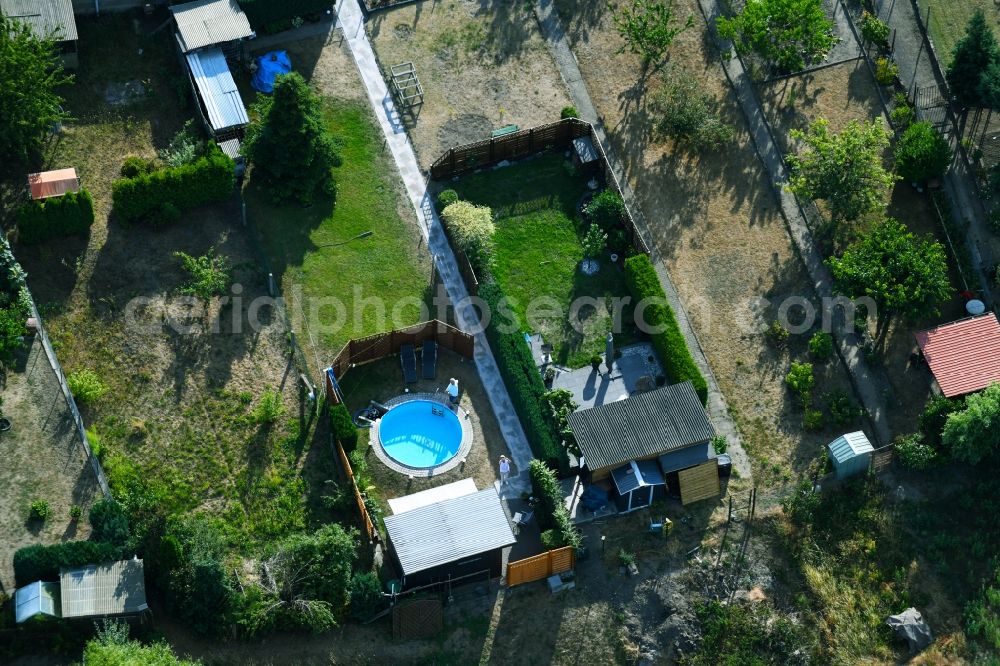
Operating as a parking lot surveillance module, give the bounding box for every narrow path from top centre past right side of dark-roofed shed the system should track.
[535,0,750,479]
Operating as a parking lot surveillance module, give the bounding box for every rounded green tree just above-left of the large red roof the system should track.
[827,218,951,346]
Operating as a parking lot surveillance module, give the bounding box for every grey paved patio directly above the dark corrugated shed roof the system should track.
[548,343,664,409]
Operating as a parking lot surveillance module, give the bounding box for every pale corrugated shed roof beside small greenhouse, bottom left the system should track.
[59,559,148,618]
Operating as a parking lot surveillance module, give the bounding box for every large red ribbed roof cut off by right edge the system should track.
[915,312,1000,398]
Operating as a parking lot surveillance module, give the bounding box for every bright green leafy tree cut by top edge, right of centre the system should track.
[716,0,837,72]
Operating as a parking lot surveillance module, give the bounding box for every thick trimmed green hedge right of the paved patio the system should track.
[625,254,708,405]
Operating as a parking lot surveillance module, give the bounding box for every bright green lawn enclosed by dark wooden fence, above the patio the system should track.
[455,154,636,367]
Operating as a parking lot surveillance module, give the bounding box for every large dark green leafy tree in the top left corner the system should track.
[0,14,73,171]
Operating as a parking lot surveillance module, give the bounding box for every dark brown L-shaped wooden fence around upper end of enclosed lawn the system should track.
[430,118,649,255]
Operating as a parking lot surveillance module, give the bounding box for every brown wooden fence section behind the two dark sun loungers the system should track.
[326,319,475,405]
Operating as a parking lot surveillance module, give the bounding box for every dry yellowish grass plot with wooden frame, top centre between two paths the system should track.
[367,0,570,169]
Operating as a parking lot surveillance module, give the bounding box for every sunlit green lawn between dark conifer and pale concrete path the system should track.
[246,100,431,363]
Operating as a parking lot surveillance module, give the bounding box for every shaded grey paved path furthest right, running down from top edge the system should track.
[876,0,993,303]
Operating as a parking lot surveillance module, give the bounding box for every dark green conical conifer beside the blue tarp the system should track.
[243,72,341,204]
